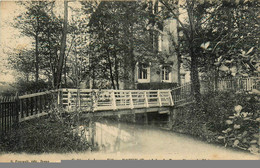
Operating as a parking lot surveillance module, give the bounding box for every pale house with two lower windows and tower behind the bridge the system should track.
[135,18,184,89]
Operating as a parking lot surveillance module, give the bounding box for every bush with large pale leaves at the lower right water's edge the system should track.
[218,105,260,153]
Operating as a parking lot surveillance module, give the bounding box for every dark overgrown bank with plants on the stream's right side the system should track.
[173,92,260,153]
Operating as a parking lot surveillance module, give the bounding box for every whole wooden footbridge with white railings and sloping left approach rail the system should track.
[16,85,190,122]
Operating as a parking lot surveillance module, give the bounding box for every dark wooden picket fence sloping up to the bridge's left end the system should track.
[0,90,58,137]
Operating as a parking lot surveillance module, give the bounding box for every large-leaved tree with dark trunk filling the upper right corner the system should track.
[160,0,259,105]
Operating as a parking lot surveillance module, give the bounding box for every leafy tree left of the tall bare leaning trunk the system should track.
[12,2,61,87]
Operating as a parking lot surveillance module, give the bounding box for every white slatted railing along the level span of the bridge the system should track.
[59,89,173,111]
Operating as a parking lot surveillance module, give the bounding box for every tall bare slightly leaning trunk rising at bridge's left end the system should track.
[56,1,68,88]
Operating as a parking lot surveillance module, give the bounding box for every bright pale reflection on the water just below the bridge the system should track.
[76,121,137,152]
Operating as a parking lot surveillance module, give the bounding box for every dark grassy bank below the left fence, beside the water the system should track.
[0,116,89,153]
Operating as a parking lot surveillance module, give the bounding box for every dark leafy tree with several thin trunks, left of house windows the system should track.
[86,1,156,89]
